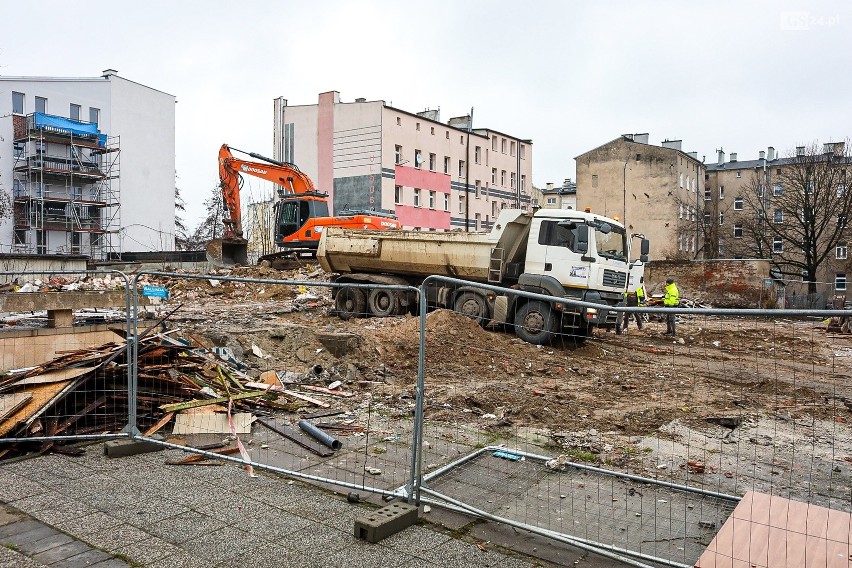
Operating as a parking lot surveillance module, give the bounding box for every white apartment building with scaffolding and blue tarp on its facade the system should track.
[0,69,175,259]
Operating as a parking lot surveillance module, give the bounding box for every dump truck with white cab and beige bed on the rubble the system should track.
[317,209,649,344]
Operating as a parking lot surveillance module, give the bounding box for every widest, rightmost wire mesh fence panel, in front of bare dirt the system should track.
[419,279,852,566]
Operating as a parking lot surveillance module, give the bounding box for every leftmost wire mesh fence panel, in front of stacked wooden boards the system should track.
[0,270,130,457]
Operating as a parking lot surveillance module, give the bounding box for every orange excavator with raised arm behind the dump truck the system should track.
[207,144,401,266]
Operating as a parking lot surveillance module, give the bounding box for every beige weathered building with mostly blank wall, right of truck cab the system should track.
[575,133,704,260]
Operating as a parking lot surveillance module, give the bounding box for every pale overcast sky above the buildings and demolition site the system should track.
[0,0,852,226]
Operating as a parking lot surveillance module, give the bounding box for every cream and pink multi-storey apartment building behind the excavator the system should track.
[274,91,532,231]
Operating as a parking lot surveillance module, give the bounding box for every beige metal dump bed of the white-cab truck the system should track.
[317,228,496,282]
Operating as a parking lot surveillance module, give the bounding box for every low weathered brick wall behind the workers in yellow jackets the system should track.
[645,259,775,308]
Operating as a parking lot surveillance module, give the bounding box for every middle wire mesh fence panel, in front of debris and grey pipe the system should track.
[133,269,417,500]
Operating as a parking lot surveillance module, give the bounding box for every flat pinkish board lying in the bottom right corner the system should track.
[695,491,852,568]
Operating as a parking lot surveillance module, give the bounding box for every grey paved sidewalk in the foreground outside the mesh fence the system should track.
[0,445,551,568]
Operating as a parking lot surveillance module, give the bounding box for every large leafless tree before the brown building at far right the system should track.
[743,142,852,293]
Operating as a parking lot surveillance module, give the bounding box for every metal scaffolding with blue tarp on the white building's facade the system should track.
[12,113,121,260]
